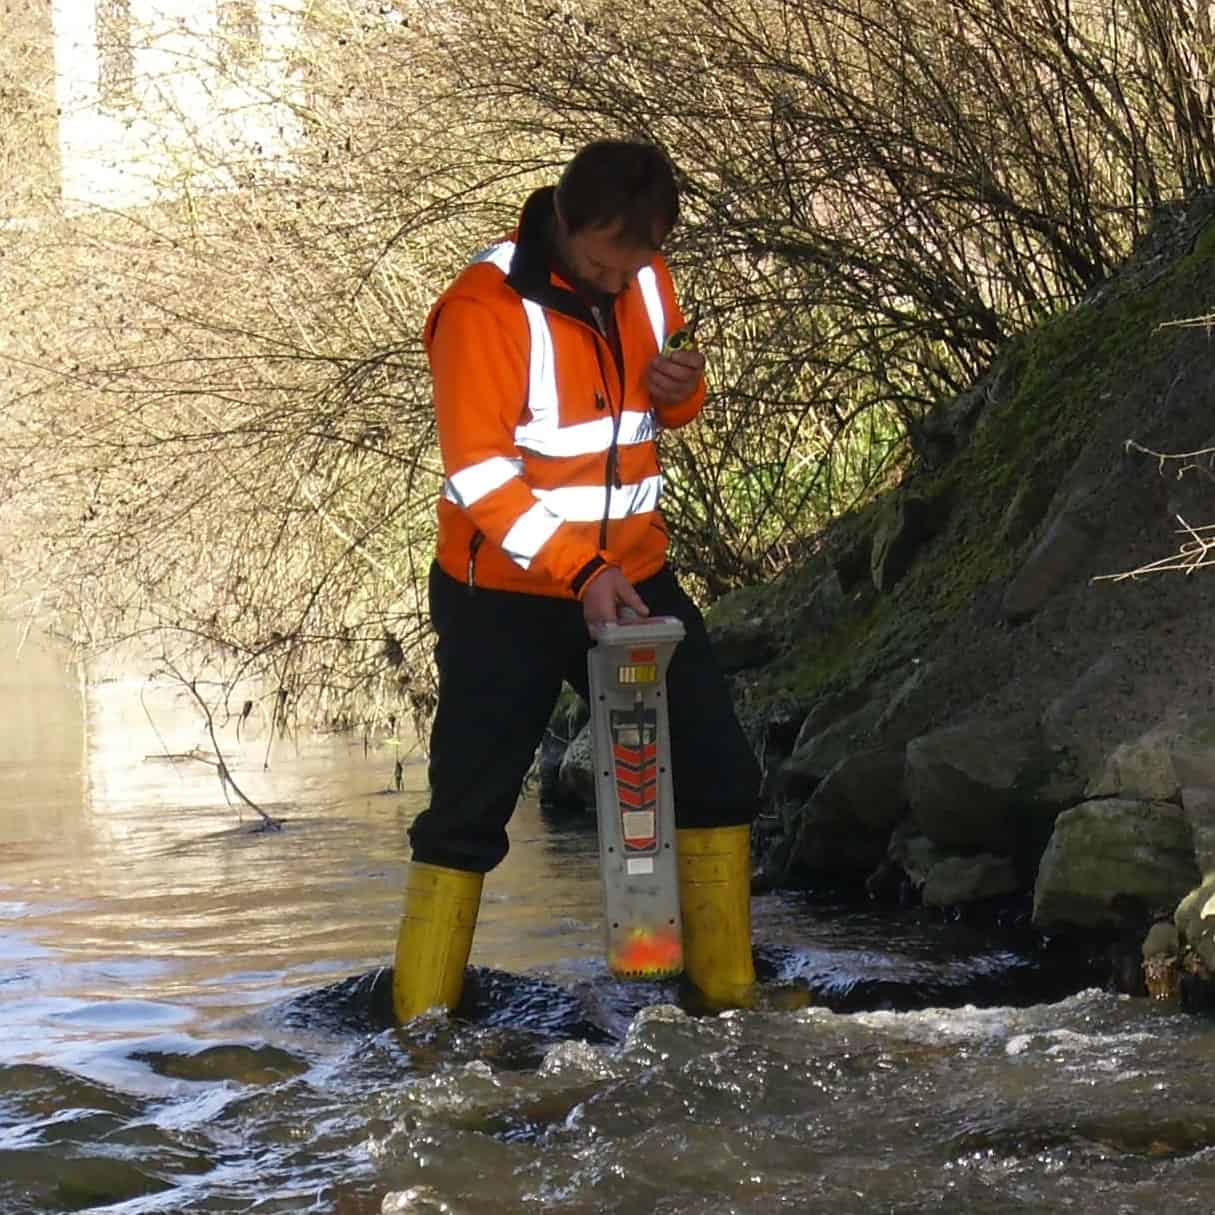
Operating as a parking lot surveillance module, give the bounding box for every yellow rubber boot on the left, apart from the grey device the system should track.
[392,861,485,1024]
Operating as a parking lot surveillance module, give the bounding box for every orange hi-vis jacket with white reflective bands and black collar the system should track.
[424,188,705,598]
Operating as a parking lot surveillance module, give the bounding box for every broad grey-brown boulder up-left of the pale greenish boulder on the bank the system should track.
[906,716,1084,855]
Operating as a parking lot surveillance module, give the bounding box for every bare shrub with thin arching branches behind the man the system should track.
[0,0,1215,720]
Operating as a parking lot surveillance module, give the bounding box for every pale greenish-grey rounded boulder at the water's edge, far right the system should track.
[1034,798,1199,928]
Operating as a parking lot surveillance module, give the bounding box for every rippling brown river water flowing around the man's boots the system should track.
[0,626,1215,1215]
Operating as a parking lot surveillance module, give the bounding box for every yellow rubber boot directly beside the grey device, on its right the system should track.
[676,825,756,1010]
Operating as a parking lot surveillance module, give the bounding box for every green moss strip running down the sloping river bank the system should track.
[724,204,1215,711]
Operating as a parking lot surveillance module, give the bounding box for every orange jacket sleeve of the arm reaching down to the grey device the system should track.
[426,296,604,594]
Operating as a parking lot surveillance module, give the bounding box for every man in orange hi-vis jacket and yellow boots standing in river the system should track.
[394,141,759,1022]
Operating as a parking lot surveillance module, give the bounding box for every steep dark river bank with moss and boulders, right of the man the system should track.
[546,197,1215,1007]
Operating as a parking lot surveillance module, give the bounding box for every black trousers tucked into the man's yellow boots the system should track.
[409,564,759,872]
